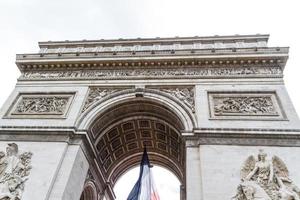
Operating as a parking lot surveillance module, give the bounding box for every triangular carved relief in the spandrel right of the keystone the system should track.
[160,87,195,112]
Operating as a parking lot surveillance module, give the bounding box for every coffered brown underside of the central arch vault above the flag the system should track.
[78,92,196,199]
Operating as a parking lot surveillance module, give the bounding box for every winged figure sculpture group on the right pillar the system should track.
[232,150,300,200]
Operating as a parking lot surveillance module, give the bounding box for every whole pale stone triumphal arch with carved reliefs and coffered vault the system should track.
[0,35,300,200]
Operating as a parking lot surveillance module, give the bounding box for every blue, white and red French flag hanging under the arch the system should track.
[127,148,159,200]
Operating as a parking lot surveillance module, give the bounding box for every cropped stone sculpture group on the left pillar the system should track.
[0,143,32,200]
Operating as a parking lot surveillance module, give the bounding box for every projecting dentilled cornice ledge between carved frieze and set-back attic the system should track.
[16,47,288,72]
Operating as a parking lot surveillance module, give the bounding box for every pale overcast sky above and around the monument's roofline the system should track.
[0,0,300,198]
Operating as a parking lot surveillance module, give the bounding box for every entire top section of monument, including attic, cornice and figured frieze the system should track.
[16,35,289,80]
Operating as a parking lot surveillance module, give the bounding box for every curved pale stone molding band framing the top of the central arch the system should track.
[76,89,197,132]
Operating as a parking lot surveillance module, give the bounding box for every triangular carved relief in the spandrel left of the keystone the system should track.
[82,87,122,112]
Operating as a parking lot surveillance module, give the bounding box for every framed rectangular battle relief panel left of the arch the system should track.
[8,94,73,117]
